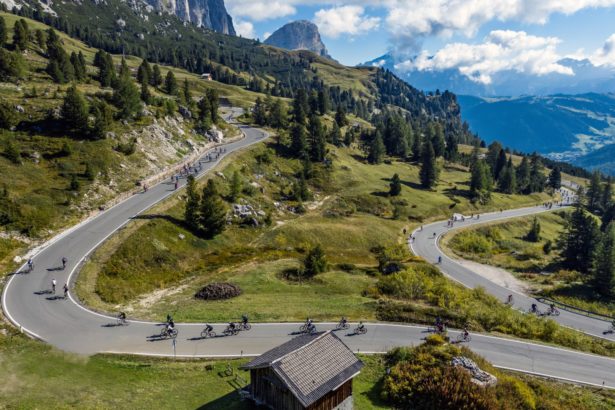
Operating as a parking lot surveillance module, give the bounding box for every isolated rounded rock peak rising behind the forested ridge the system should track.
[265,20,331,58]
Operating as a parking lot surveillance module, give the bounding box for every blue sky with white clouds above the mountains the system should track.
[226,0,615,82]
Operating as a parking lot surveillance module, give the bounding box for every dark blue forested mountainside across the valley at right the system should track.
[459,94,615,161]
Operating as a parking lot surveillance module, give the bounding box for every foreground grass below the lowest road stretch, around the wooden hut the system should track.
[0,326,615,410]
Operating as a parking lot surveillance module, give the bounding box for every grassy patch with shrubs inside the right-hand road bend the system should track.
[443,212,615,316]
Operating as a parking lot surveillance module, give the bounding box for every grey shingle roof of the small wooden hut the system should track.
[244,331,363,407]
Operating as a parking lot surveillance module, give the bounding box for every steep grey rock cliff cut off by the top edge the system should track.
[146,0,236,36]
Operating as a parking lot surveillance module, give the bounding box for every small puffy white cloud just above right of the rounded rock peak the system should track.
[314,6,380,38]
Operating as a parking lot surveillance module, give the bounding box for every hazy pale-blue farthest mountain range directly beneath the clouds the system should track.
[362,54,615,97]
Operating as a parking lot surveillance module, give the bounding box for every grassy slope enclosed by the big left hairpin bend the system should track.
[78,140,546,320]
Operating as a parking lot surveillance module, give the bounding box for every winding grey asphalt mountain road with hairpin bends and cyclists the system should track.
[2,110,615,388]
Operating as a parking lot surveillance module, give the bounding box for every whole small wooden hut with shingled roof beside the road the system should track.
[243,331,363,410]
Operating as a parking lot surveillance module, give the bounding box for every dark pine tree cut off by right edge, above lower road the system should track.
[592,223,615,300]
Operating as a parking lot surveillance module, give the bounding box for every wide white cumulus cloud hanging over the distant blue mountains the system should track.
[396,30,574,84]
